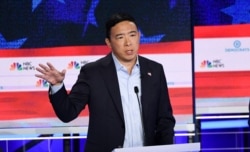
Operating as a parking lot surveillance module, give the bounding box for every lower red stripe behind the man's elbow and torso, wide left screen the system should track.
[0,88,192,120]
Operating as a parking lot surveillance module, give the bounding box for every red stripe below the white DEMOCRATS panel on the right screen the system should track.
[195,71,250,98]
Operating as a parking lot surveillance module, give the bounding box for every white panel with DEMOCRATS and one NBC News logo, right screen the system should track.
[195,38,250,72]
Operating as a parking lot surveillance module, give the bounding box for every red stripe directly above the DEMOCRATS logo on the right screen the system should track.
[194,24,250,38]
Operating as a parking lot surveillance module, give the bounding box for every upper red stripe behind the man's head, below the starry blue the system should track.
[0,41,191,57]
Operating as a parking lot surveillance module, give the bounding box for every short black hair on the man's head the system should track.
[106,13,138,39]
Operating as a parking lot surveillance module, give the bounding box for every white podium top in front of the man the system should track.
[112,143,200,152]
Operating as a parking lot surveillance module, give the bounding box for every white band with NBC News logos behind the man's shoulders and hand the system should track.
[0,53,192,92]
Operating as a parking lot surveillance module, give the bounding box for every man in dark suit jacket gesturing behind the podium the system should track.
[36,13,175,152]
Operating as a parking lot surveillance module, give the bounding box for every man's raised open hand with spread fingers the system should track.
[35,62,66,85]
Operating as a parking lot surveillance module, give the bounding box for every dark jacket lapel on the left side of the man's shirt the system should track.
[98,53,124,122]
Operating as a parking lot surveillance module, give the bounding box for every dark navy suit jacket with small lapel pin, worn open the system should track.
[50,53,175,152]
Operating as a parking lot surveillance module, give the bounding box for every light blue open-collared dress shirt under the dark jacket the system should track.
[112,54,143,147]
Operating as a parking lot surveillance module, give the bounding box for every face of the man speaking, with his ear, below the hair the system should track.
[105,21,140,64]
